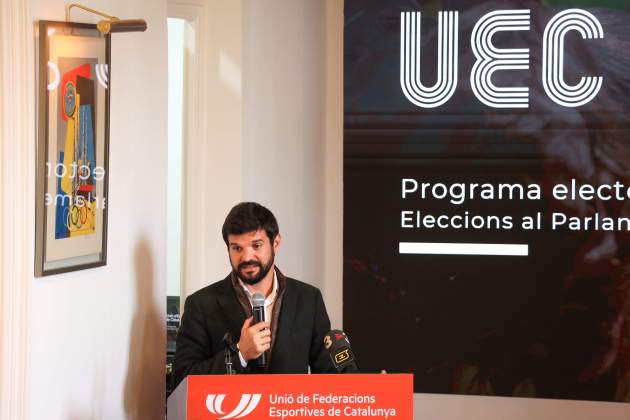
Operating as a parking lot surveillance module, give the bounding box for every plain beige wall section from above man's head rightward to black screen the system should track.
[242,0,343,328]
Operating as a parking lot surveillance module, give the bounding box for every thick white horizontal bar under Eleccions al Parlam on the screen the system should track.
[398,242,529,257]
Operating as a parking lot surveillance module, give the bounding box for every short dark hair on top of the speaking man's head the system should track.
[222,202,279,246]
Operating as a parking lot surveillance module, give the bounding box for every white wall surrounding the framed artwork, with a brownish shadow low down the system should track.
[28,0,167,420]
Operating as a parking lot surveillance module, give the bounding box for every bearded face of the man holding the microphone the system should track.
[228,229,280,285]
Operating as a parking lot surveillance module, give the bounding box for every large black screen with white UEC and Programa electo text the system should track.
[343,0,630,402]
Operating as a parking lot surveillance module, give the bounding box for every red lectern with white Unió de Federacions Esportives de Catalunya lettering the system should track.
[167,374,413,420]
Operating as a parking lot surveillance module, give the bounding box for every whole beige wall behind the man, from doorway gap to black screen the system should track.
[180,0,342,334]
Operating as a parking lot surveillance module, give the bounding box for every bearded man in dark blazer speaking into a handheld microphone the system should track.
[173,203,334,388]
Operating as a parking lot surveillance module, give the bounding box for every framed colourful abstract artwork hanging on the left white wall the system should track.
[35,21,111,277]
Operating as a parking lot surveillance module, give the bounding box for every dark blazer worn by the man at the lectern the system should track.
[172,270,335,389]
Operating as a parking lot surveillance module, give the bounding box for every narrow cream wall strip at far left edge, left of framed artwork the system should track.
[0,0,35,419]
